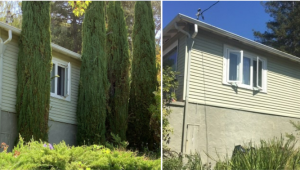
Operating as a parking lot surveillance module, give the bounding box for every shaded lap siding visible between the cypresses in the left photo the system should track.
[1,28,80,124]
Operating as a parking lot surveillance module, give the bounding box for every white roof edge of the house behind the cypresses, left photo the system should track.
[0,22,81,60]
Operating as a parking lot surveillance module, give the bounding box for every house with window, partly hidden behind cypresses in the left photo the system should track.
[0,22,81,150]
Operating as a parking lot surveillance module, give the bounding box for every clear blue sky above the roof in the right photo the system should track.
[163,1,272,40]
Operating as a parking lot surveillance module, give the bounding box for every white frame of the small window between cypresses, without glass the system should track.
[50,59,71,101]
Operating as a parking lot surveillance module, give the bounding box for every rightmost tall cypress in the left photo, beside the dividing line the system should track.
[127,1,160,150]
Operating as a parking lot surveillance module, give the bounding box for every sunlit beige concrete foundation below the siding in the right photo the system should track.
[168,102,300,162]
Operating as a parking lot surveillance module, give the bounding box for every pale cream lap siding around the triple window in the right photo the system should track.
[189,35,300,117]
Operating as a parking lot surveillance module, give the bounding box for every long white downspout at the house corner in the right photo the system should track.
[175,22,198,153]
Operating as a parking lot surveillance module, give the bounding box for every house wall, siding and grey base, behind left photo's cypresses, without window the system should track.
[0,29,81,146]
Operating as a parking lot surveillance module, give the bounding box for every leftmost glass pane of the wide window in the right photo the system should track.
[229,52,241,81]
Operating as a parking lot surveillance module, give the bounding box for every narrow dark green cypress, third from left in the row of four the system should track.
[106,1,130,140]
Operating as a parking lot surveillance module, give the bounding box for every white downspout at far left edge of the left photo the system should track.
[0,30,12,133]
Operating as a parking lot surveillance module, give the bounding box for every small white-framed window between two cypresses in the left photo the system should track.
[51,61,71,101]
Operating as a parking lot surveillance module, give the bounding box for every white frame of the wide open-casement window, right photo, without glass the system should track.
[222,44,268,93]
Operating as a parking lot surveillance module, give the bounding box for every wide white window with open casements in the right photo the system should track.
[223,45,267,92]
